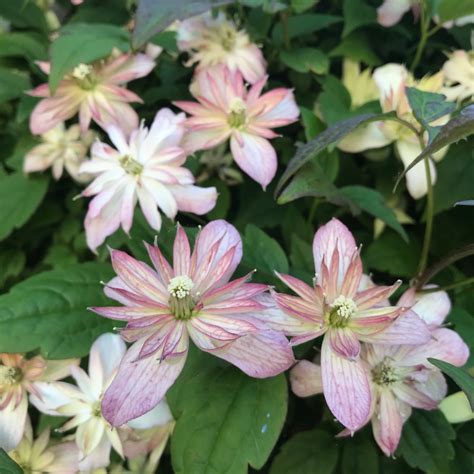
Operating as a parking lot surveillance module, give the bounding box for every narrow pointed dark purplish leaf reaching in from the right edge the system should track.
[395,105,474,186]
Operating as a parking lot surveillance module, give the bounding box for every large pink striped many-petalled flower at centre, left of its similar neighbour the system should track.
[91,220,294,426]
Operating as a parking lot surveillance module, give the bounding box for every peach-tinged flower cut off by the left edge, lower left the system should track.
[0,353,79,451]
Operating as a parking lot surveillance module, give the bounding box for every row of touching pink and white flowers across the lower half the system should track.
[0,219,469,466]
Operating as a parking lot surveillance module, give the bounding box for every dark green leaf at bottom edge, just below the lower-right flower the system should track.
[397,410,456,474]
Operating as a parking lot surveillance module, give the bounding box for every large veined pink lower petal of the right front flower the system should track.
[321,337,372,432]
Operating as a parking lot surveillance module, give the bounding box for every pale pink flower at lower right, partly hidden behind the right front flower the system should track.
[290,289,469,456]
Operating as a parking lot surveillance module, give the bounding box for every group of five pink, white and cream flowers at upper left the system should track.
[24,13,299,251]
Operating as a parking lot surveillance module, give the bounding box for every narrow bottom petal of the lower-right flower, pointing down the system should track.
[372,390,403,456]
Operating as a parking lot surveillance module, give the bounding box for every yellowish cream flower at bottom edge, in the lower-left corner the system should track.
[8,419,79,474]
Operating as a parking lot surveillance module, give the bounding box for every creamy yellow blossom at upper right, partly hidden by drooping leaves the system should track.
[338,63,447,199]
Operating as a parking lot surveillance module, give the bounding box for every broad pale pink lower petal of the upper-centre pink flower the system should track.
[230,132,278,190]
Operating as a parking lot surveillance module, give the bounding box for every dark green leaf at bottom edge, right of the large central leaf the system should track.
[270,429,339,474]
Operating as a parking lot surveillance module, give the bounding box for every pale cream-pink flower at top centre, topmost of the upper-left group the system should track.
[177,12,266,84]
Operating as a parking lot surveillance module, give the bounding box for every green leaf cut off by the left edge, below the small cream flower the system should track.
[0,172,48,240]
